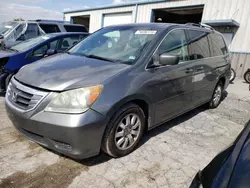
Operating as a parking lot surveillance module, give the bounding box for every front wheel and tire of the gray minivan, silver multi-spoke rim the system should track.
[102,103,146,158]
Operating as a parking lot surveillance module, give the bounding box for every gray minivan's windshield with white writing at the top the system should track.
[68,26,158,64]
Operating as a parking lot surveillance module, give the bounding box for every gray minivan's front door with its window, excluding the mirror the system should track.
[151,29,194,124]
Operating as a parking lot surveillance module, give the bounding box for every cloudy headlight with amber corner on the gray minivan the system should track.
[45,85,103,114]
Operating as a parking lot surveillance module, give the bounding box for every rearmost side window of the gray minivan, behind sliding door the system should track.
[209,33,228,57]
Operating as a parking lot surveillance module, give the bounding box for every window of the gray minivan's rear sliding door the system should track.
[187,30,210,60]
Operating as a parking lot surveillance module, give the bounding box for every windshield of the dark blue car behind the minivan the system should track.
[10,35,52,52]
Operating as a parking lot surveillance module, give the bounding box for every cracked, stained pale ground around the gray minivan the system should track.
[0,80,250,188]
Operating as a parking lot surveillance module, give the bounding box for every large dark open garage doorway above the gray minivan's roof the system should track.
[152,6,204,24]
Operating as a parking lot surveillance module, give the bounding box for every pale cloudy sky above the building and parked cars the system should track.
[0,0,144,23]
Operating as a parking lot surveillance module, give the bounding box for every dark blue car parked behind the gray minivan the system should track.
[0,33,88,92]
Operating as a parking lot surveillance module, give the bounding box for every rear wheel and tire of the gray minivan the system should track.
[209,81,223,109]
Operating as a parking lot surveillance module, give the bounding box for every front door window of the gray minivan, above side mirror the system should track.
[158,29,188,61]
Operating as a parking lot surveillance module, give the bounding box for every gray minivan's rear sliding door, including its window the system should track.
[187,29,214,106]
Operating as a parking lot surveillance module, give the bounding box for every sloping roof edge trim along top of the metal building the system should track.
[63,0,168,14]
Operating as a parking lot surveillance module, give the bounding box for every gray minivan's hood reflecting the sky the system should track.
[15,54,130,91]
